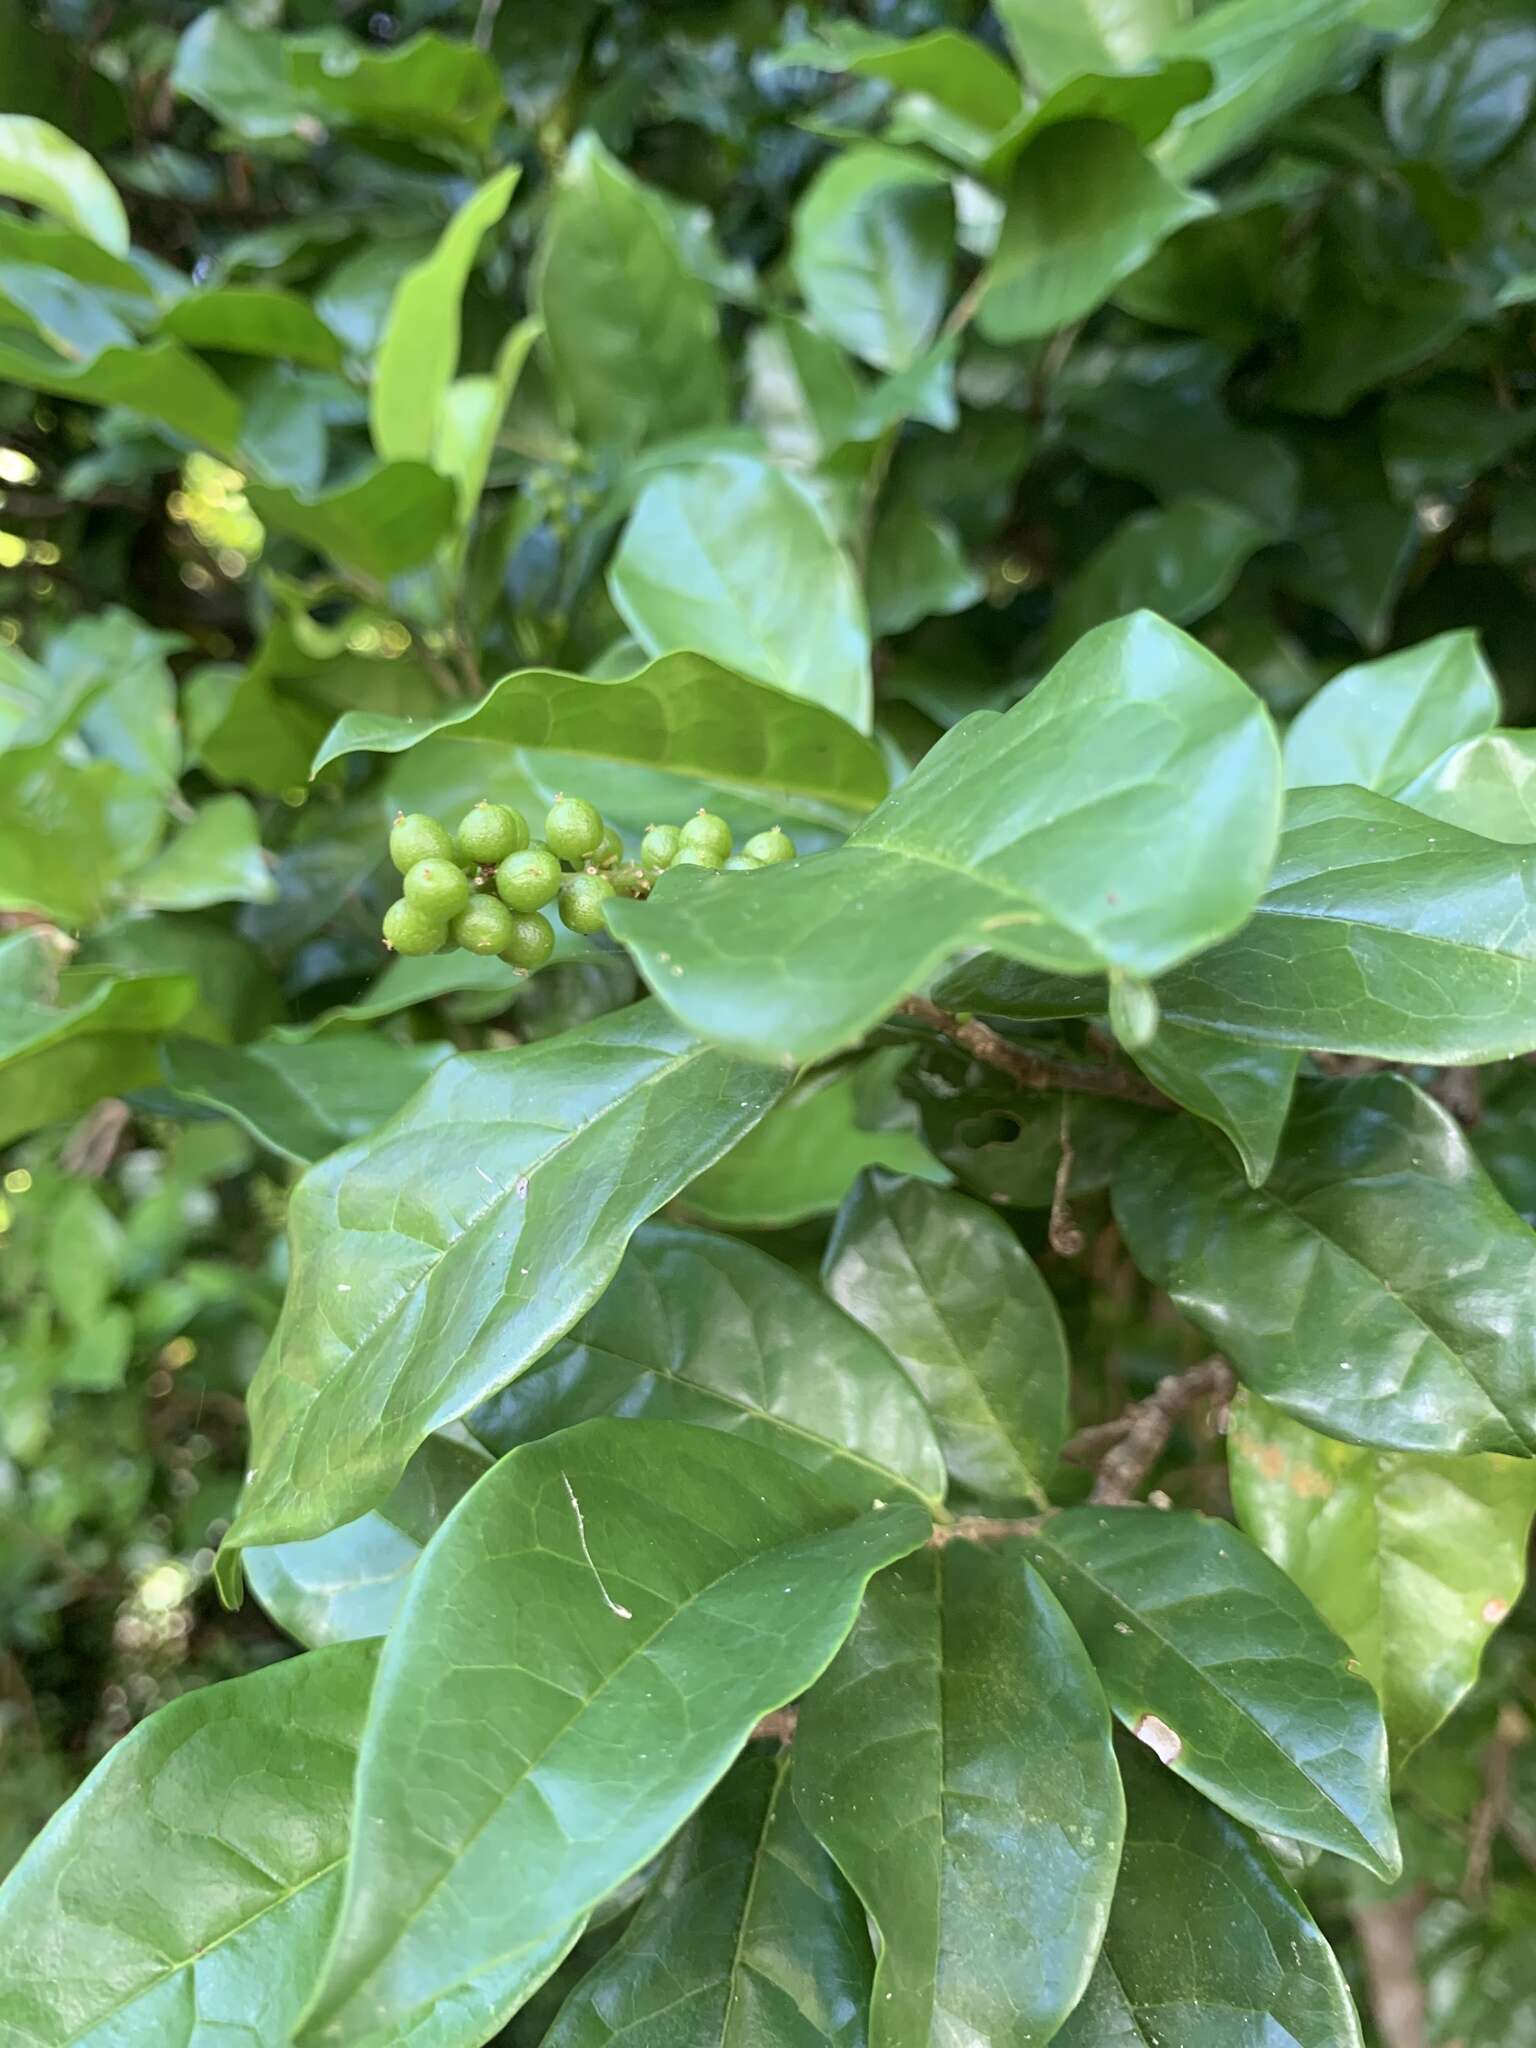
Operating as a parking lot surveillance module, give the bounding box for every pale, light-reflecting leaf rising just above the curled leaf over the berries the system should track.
[608,455,870,733]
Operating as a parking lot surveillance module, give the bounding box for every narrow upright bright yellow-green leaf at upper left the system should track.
[369,164,518,468]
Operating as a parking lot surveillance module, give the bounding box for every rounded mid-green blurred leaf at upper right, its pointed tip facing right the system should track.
[977,121,1214,342]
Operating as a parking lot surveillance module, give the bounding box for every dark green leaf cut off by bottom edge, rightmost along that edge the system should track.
[1055,1743,1362,2048]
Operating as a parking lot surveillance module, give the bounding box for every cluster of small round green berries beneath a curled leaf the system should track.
[383,797,795,971]
